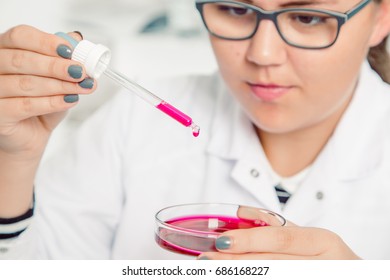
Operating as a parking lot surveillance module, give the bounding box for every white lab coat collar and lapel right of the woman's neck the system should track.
[283,63,390,225]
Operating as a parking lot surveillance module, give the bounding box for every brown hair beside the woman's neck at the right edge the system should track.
[368,0,390,84]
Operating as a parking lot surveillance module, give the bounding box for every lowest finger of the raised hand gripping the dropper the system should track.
[0,95,78,123]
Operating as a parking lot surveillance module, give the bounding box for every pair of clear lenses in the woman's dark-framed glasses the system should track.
[203,2,339,48]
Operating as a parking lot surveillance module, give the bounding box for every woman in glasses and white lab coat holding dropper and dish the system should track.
[0,0,390,259]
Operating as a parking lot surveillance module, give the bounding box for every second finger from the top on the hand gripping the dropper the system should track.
[0,49,86,81]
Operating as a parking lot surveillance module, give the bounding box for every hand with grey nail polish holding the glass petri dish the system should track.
[198,223,359,260]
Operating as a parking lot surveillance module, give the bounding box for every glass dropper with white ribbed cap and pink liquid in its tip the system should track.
[72,40,200,137]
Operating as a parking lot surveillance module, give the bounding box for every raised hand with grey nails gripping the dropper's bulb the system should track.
[0,25,96,160]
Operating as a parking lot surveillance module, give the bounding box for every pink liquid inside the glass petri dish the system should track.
[155,215,268,256]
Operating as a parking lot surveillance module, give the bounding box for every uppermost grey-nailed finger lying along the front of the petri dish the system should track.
[215,226,341,256]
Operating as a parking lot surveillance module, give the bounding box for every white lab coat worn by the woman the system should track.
[3,64,390,259]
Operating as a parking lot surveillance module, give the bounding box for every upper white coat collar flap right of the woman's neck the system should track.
[328,62,390,181]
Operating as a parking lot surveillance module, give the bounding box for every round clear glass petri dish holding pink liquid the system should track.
[155,203,286,256]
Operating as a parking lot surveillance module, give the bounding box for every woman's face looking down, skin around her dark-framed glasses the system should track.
[210,0,384,133]
